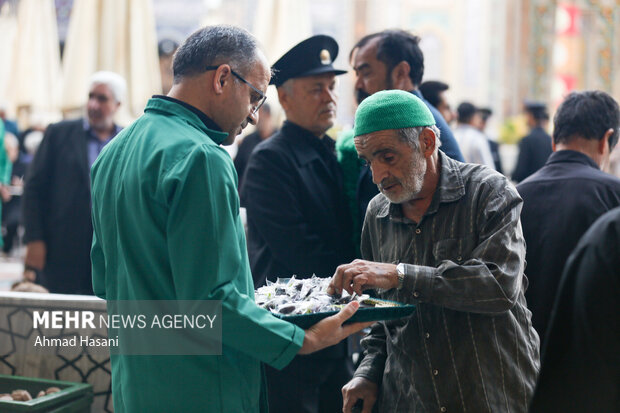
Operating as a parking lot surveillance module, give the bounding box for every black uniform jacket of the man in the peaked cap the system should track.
[241,121,353,287]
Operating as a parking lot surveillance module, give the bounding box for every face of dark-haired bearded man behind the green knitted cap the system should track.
[353,39,392,103]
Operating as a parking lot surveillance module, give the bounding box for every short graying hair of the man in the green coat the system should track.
[172,25,259,84]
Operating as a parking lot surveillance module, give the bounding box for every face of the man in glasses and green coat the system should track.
[216,56,271,145]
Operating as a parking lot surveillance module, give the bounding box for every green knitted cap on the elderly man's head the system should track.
[355,90,435,136]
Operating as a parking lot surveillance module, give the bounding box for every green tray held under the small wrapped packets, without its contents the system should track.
[271,298,415,328]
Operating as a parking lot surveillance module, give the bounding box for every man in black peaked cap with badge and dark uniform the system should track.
[241,35,353,413]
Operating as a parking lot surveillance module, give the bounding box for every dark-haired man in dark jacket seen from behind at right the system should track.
[517,91,620,345]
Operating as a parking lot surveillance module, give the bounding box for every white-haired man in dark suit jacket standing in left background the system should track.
[23,72,127,294]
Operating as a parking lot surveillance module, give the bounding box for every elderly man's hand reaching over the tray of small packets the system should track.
[327,260,398,295]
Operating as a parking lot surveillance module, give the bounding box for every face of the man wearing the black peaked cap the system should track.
[278,73,338,136]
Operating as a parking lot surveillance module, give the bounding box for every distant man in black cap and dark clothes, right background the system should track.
[512,100,552,182]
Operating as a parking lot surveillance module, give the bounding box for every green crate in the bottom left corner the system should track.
[0,374,93,413]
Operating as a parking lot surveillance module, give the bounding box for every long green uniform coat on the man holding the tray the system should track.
[91,98,304,413]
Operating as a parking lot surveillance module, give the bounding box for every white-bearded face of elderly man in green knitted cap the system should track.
[355,129,427,204]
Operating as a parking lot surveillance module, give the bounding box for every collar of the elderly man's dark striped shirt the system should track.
[377,150,465,222]
